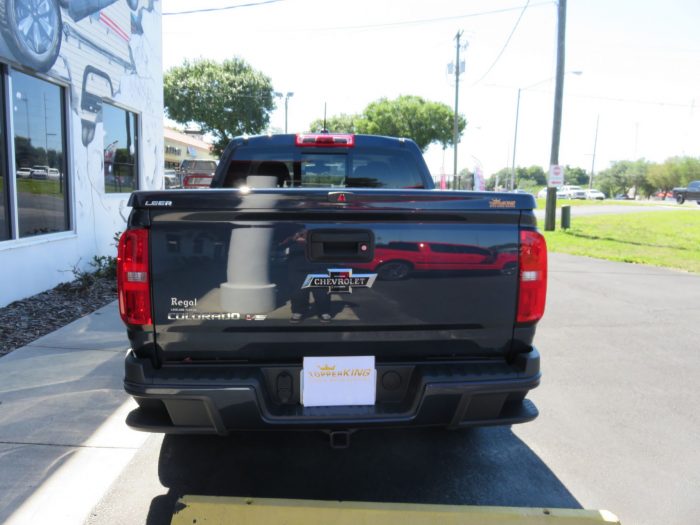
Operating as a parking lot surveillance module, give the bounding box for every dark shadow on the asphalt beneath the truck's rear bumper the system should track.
[147,427,581,525]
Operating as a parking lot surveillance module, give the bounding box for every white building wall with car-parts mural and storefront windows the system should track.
[0,0,164,304]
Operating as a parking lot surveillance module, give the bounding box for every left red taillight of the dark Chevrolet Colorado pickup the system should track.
[117,229,153,325]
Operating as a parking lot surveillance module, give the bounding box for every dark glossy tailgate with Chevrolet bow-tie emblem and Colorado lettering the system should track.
[141,190,534,362]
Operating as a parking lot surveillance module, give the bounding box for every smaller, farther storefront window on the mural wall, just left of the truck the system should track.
[102,104,139,193]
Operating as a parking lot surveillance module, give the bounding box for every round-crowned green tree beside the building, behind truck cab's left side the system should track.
[163,58,275,155]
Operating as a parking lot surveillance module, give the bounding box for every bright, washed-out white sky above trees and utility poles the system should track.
[162,0,700,180]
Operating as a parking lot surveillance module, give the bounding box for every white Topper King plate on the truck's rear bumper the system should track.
[301,356,377,407]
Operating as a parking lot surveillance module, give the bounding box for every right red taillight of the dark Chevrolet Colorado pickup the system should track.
[517,230,547,323]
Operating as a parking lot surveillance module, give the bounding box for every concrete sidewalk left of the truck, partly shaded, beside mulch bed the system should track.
[0,301,148,524]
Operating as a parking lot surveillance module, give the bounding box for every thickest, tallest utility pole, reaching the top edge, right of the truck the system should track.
[544,0,566,231]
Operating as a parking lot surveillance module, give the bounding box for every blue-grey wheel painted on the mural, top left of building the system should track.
[0,0,63,72]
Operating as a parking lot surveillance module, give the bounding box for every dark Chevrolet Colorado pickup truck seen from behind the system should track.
[118,134,547,444]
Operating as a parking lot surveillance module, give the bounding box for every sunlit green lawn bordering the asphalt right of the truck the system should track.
[545,210,700,273]
